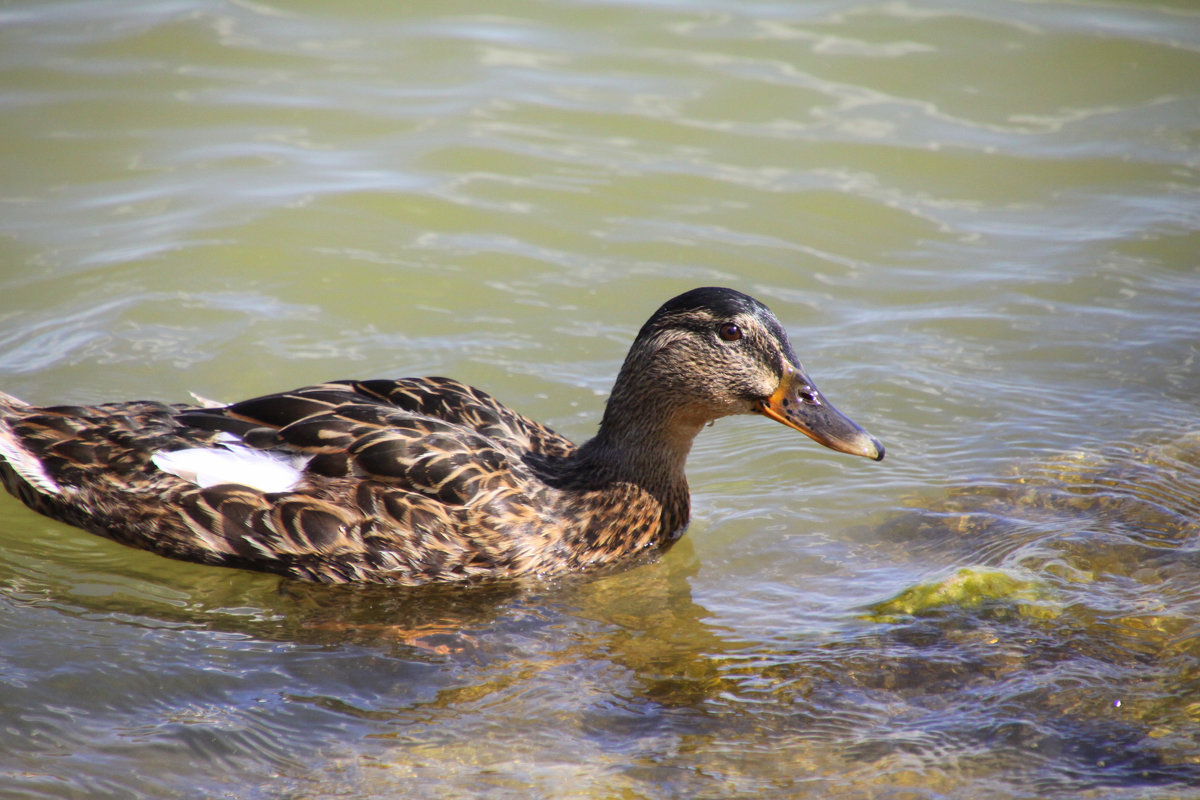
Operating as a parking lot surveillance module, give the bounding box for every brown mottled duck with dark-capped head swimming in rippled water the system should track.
[0,287,884,587]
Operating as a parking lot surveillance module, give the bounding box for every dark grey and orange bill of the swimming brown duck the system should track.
[756,366,883,461]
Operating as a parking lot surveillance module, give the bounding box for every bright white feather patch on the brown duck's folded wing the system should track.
[150,444,310,492]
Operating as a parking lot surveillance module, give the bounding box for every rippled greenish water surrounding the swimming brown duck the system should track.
[0,0,1200,798]
